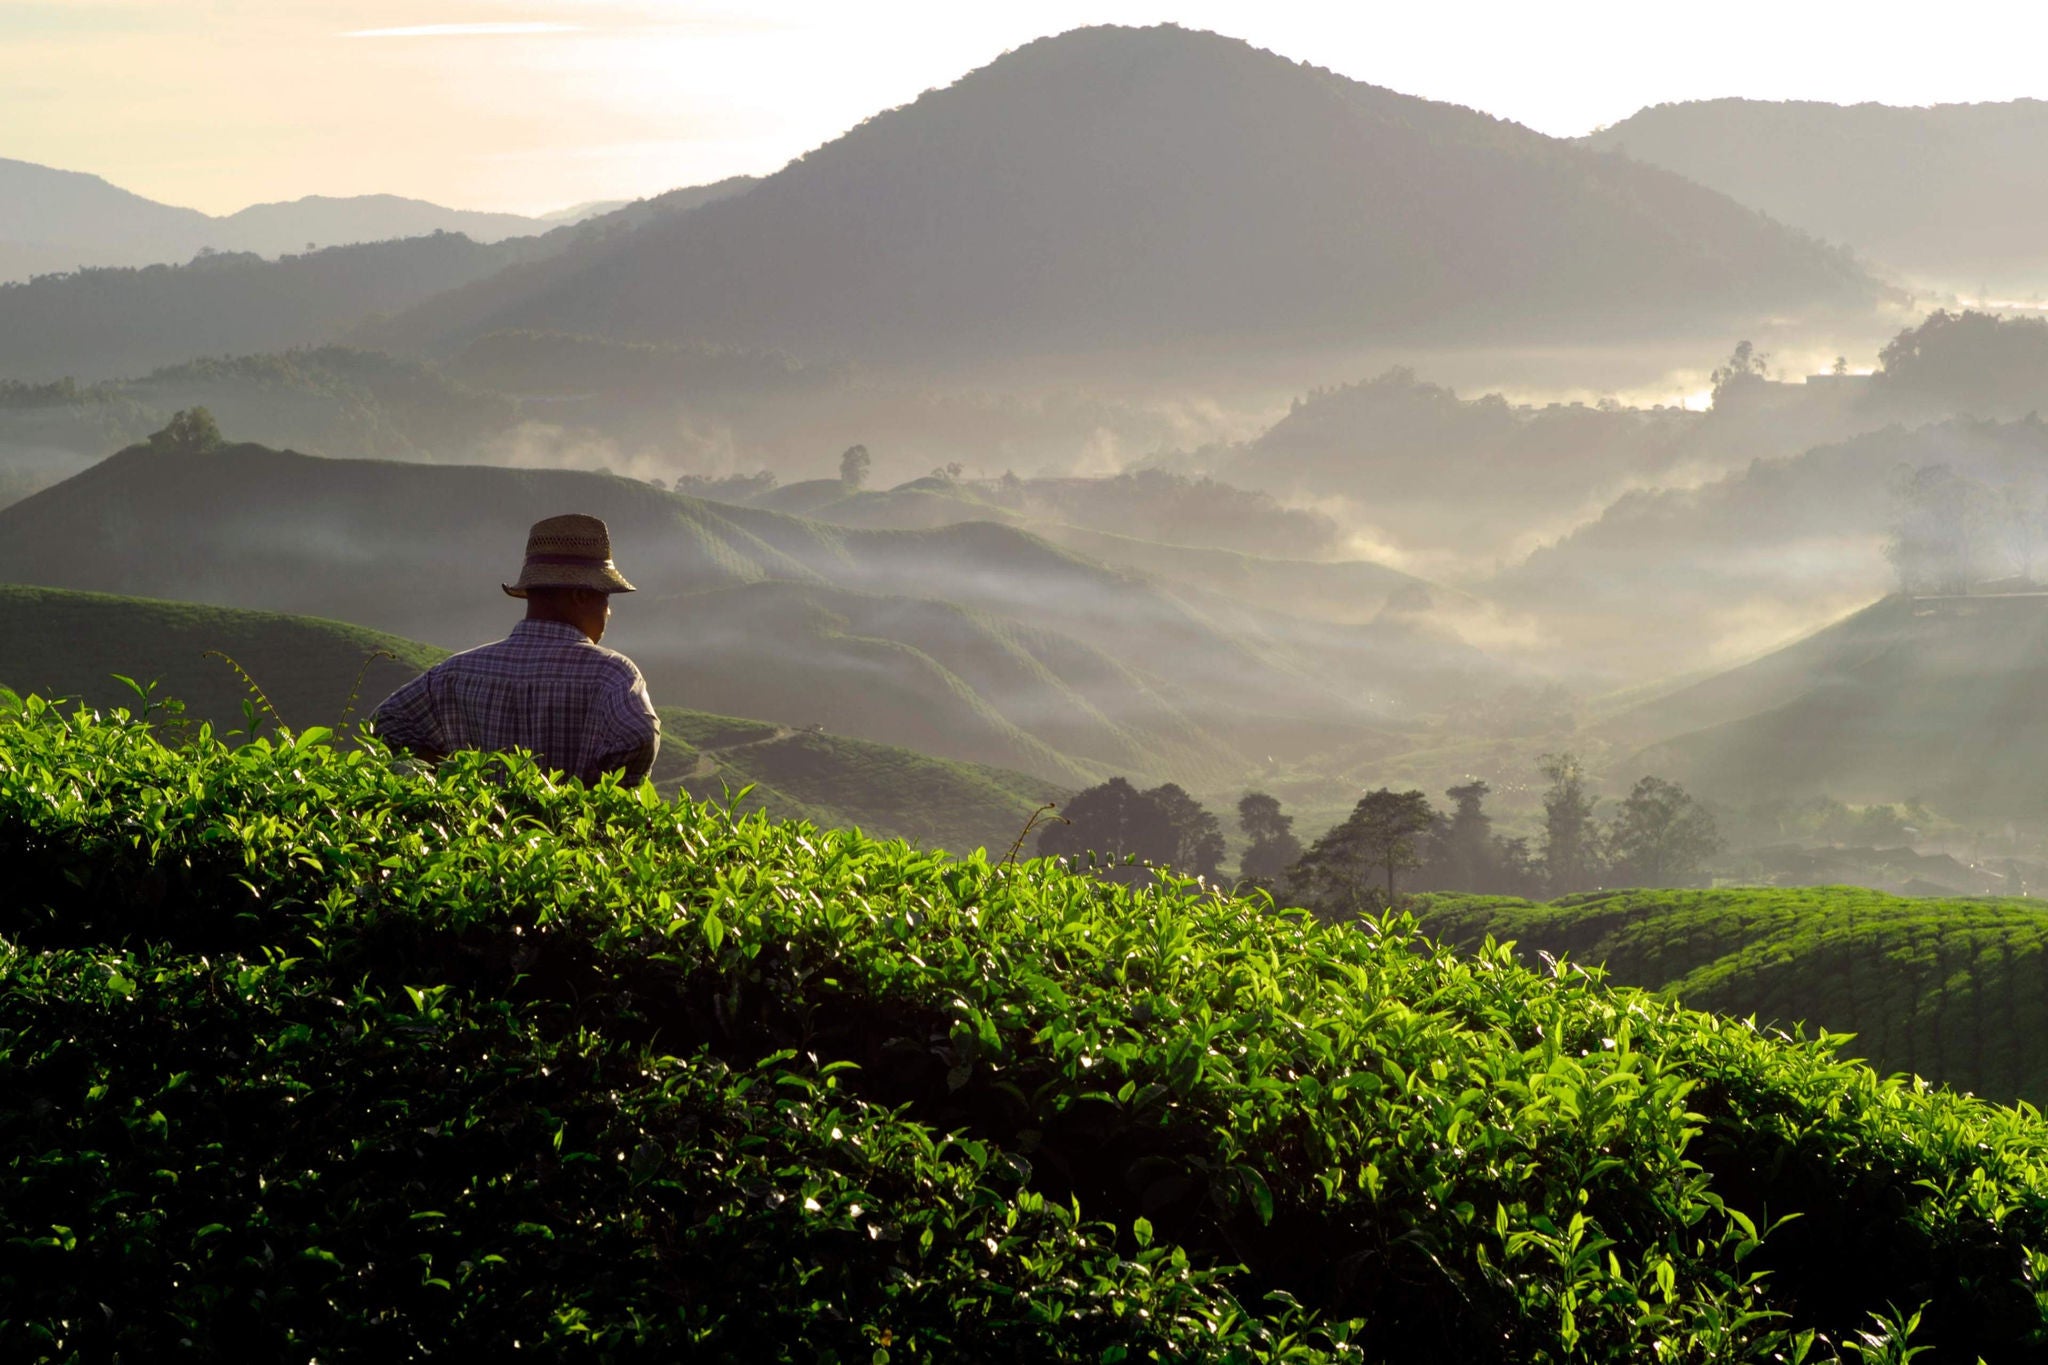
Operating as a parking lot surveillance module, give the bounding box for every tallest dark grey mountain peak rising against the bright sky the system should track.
[376,27,1878,360]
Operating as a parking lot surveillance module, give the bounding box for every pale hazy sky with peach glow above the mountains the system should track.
[12,0,2048,213]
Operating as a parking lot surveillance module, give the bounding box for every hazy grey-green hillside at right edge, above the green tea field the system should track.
[1610,593,2048,819]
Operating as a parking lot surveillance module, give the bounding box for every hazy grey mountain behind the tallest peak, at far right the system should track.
[1585,100,2048,297]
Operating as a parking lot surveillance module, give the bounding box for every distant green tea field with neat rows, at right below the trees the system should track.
[1417,886,2048,1105]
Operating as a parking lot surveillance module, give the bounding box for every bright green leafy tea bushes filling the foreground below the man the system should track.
[0,700,2048,1363]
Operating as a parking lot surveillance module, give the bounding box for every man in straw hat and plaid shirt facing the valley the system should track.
[371,514,662,786]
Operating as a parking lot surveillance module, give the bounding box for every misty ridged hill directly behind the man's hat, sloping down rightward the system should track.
[0,446,1497,786]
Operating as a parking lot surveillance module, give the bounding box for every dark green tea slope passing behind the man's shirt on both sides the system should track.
[0,585,1069,853]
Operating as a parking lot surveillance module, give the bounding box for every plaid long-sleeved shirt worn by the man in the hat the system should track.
[371,620,662,784]
